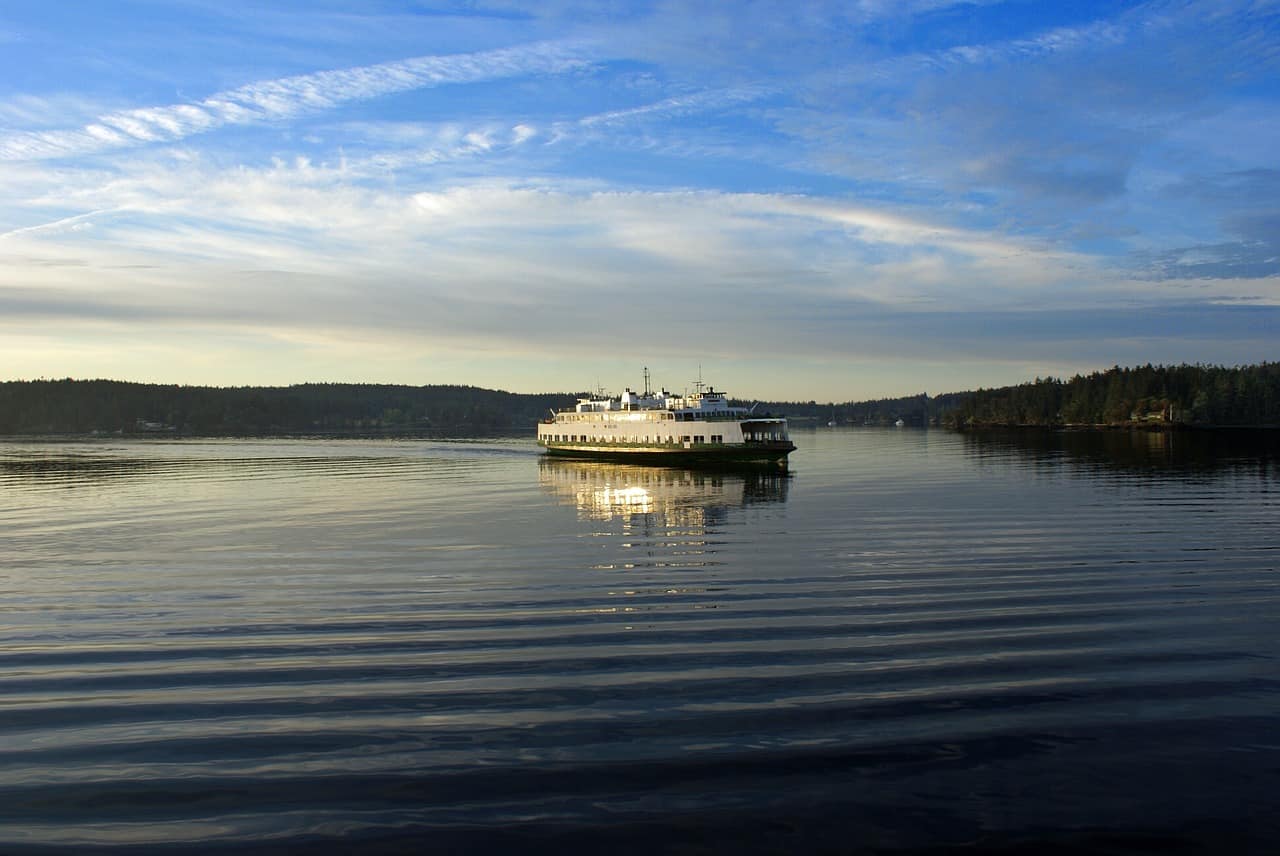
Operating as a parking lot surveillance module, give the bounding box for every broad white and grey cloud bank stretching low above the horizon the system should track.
[0,152,1280,395]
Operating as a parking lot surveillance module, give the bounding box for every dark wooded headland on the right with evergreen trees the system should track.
[946,362,1280,427]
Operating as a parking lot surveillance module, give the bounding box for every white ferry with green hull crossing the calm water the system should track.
[538,369,796,467]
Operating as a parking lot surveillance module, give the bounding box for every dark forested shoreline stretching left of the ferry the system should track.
[0,380,573,435]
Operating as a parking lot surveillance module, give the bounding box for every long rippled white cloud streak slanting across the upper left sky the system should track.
[0,42,590,160]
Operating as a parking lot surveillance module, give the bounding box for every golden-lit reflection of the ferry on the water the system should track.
[539,458,790,527]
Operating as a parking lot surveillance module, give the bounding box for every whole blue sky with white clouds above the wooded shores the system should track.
[0,0,1280,402]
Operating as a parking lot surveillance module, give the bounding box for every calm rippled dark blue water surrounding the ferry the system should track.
[0,429,1280,853]
